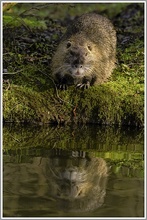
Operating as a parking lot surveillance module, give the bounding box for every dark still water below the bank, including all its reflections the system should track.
[3,126,144,217]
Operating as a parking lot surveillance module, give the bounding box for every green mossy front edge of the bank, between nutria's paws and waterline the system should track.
[4,80,144,126]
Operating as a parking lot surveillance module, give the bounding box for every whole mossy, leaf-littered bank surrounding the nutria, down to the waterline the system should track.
[3,3,144,127]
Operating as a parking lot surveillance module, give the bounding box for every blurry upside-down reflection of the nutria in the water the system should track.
[44,151,108,212]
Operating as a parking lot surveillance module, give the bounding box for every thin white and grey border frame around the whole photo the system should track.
[0,0,147,219]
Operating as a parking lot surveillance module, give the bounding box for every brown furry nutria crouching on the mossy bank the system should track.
[52,13,116,89]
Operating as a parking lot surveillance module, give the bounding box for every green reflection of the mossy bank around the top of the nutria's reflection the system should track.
[3,124,144,178]
